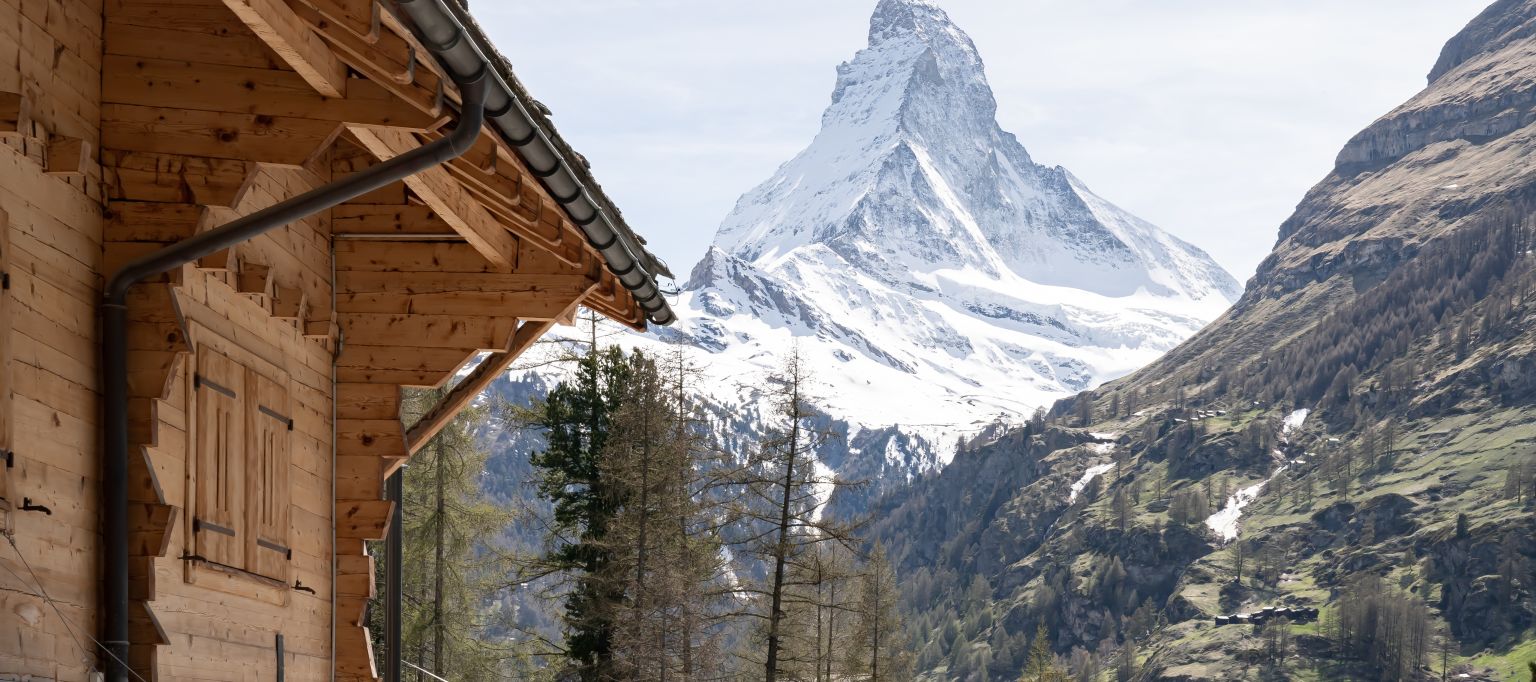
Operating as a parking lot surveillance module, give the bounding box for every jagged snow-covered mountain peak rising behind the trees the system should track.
[516,0,1240,491]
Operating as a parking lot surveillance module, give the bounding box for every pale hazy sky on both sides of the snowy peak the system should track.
[473,0,1488,281]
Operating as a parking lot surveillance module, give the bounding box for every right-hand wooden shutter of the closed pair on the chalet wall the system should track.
[246,370,293,582]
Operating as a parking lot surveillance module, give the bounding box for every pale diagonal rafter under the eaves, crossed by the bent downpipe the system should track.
[349,126,518,270]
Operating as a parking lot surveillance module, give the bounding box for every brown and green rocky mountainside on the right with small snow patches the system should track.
[879,0,1536,680]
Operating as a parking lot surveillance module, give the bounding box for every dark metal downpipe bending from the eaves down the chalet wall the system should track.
[101,68,492,682]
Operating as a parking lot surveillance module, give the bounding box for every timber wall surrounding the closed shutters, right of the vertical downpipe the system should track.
[101,0,336,680]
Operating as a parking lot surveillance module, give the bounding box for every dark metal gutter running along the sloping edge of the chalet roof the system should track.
[395,0,677,326]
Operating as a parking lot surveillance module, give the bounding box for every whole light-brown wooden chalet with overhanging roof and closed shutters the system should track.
[0,0,671,682]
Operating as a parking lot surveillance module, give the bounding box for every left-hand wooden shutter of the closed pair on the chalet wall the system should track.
[192,346,246,568]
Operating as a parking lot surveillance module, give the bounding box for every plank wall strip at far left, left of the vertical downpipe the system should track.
[0,0,101,679]
